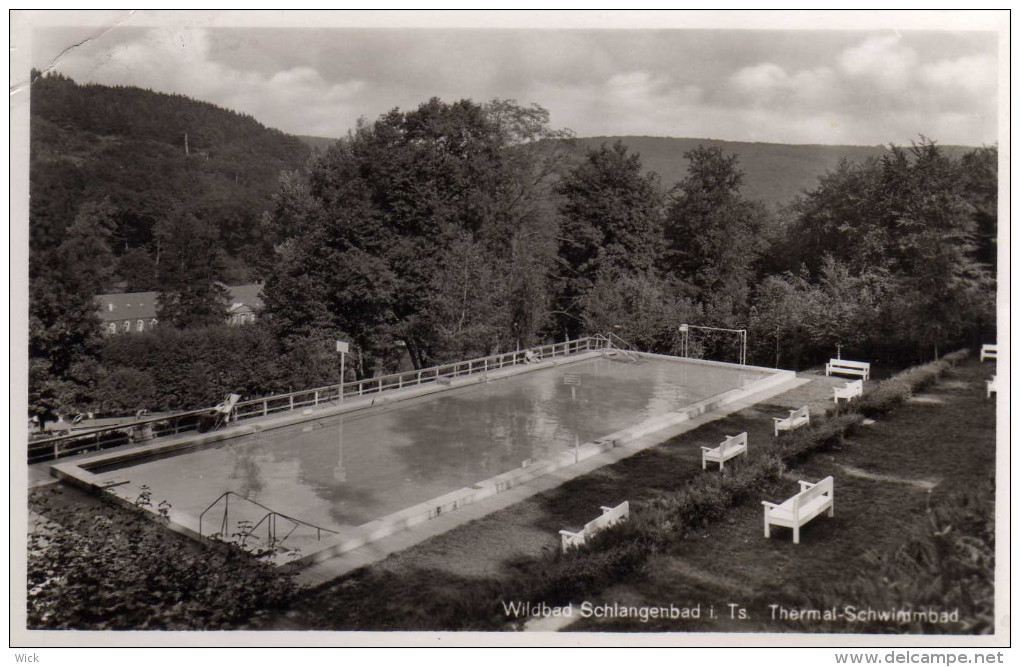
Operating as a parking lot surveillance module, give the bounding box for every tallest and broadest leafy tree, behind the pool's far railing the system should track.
[266,99,563,373]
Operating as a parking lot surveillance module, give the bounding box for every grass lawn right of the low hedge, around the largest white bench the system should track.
[570,360,996,632]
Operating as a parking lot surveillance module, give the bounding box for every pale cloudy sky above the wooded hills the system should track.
[23,13,1000,146]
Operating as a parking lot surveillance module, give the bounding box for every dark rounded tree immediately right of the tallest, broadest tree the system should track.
[556,142,662,336]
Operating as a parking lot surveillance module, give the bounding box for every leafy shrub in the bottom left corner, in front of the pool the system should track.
[28,490,296,630]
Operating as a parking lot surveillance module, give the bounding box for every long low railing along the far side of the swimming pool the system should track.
[29,335,612,463]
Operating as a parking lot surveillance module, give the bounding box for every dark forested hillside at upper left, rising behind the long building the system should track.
[30,73,309,291]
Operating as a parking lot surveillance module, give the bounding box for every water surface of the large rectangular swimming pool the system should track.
[65,356,772,554]
